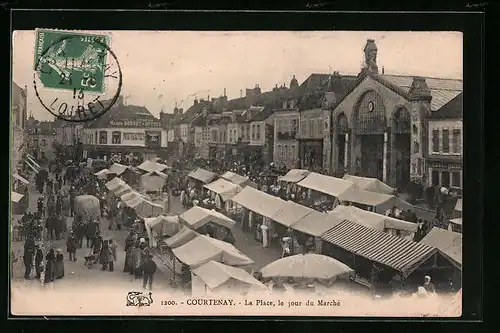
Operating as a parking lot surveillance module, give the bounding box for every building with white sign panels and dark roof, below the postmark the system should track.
[83,97,167,159]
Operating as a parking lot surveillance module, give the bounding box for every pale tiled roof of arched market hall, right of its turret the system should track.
[379,75,463,111]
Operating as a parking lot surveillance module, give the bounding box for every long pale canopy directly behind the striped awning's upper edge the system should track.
[329,205,418,232]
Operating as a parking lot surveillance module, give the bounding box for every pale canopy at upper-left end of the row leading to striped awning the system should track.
[231,186,286,219]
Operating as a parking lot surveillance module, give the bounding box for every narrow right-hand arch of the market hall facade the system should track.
[392,106,410,191]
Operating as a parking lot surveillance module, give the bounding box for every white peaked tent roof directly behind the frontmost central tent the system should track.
[172,235,254,267]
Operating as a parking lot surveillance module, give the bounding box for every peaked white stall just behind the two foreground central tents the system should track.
[179,206,235,240]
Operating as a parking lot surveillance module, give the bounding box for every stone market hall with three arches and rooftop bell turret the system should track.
[323,40,462,190]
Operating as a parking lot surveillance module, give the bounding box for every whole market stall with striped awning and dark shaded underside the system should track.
[321,220,458,290]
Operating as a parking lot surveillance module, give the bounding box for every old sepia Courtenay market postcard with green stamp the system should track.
[10,27,463,317]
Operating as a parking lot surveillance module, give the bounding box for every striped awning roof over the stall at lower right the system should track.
[321,220,438,277]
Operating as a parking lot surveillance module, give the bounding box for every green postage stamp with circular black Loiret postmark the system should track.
[34,29,110,94]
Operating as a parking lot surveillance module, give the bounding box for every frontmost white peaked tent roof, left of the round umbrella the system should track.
[193,260,267,289]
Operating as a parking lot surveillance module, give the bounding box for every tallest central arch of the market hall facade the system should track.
[353,90,387,181]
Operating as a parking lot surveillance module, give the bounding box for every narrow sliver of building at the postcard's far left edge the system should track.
[10,82,28,172]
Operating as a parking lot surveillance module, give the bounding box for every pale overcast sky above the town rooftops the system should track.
[12,31,463,120]
